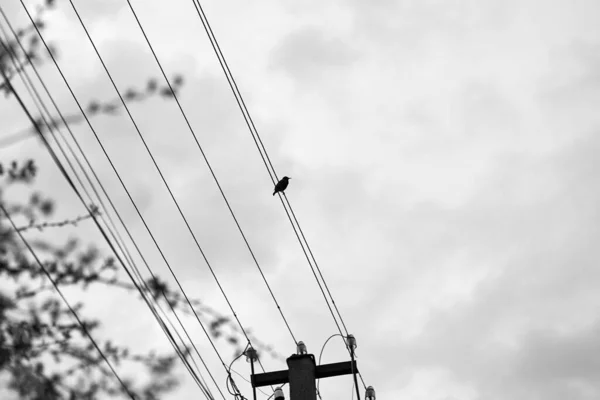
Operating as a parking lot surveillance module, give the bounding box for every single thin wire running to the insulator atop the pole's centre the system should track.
[127,0,297,344]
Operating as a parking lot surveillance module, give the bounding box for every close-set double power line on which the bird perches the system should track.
[192,0,366,388]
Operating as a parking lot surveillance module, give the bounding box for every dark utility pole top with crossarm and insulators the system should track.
[250,335,375,400]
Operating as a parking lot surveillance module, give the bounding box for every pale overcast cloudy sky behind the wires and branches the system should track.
[0,0,600,400]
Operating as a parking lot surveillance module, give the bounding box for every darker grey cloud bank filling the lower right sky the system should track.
[358,130,600,399]
